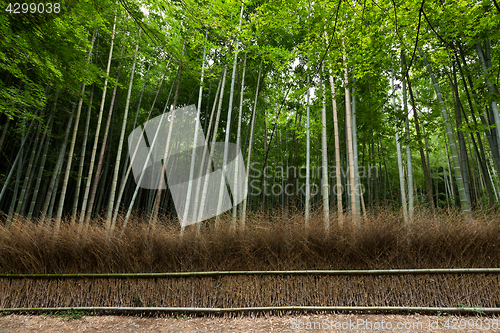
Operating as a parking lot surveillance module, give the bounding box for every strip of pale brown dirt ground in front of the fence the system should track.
[0,314,500,333]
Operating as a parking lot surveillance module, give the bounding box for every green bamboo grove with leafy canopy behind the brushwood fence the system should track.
[0,0,500,225]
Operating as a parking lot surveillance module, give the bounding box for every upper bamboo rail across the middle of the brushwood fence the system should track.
[0,268,500,279]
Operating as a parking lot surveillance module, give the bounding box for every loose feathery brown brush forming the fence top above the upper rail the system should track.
[0,211,500,273]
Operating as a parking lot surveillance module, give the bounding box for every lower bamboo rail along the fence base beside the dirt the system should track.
[0,306,500,314]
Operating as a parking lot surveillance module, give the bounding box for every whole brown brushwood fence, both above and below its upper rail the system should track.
[0,211,500,308]
